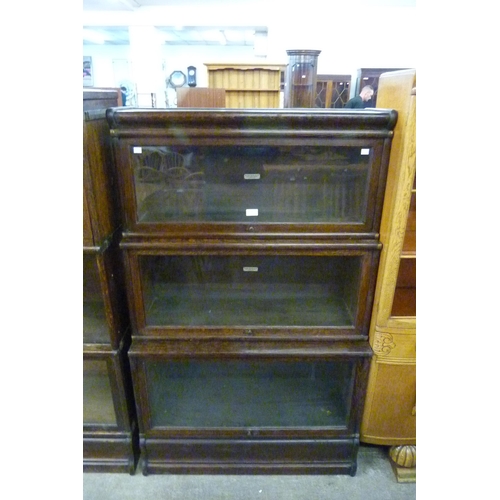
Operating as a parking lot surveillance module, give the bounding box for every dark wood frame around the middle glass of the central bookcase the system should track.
[122,240,380,340]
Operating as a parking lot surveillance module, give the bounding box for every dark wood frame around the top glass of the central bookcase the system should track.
[107,108,397,238]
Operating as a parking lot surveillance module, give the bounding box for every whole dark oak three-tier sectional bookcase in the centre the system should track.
[107,108,397,475]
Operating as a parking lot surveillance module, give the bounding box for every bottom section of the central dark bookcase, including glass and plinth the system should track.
[130,340,370,474]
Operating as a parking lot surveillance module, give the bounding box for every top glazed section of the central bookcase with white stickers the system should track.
[108,109,395,234]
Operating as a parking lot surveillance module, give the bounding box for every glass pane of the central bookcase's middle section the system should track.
[140,255,361,326]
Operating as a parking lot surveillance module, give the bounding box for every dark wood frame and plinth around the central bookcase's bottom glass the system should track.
[129,338,371,475]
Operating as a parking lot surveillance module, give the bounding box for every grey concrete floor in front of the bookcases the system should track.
[83,445,416,500]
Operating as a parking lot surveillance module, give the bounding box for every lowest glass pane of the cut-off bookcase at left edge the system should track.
[83,359,116,425]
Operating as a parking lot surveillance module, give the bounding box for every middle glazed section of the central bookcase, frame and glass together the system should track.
[121,245,379,339]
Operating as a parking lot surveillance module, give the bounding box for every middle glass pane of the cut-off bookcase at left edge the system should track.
[83,253,109,343]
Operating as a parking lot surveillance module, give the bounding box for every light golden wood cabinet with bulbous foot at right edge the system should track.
[361,70,417,481]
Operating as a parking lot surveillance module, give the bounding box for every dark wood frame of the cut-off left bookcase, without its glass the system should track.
[83,89,139,473]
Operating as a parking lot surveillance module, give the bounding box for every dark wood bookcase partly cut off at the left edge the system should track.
[82,89,138,472]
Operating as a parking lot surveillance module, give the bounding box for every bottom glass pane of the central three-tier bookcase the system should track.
[146,360,353,427]
